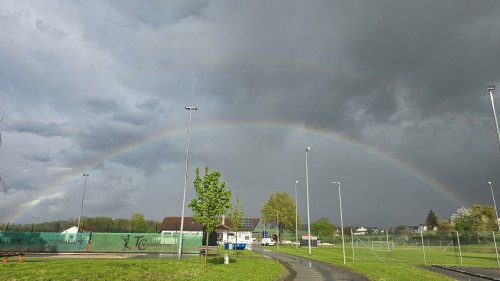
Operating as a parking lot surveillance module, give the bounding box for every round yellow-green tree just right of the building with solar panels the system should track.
[260,192,300,243]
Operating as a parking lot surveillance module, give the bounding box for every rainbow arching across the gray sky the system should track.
[5,121,467,222]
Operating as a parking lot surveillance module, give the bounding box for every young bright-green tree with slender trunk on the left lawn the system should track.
[189,167,231,267]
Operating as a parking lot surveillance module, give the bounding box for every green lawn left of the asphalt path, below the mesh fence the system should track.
[0,248,284,281]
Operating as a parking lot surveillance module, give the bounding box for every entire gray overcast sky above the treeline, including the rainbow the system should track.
[0,0,500,227]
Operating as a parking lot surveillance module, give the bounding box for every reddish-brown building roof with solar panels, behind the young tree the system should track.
[160,216,260,231]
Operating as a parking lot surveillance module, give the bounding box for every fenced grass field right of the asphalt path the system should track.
[279,244,498,281]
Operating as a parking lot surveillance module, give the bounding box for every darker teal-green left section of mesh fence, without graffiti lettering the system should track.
[0,232,90,253]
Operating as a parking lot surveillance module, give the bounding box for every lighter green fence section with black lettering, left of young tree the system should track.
[90,233,202,254]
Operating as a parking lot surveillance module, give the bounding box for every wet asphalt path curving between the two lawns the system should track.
[252,244,368,281]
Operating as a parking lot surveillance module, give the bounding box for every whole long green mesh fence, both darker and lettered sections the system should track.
[0,232,202,254]
